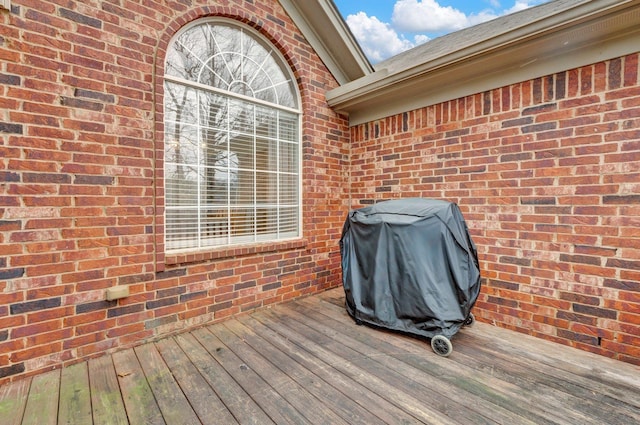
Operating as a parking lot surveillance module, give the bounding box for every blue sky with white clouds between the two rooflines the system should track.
[333,0,549,64]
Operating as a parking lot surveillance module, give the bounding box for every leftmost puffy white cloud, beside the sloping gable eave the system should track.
[347,12,414,63]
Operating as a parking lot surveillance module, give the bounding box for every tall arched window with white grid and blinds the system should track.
[164,19,301,251]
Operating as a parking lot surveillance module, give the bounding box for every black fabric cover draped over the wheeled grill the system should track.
[340,198,480,338]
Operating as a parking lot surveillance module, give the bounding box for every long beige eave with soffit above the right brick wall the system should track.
[327,0,640,126]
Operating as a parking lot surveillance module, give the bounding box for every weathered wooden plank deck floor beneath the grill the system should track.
[0,289,640,425]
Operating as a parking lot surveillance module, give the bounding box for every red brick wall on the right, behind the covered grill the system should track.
[351,54,640,364]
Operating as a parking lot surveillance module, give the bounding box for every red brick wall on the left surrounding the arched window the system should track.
[0,0,349,383]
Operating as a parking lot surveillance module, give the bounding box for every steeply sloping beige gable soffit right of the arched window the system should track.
[279,0,373,84]
